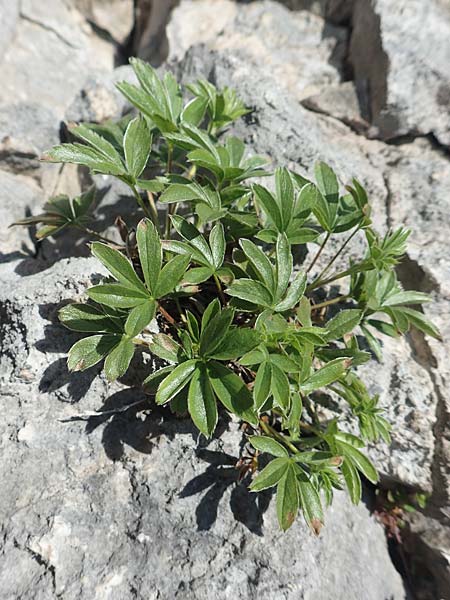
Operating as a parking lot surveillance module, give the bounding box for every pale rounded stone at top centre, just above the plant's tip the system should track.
[167,0,346,100]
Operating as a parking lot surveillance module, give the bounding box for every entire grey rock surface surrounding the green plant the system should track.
[0,0,450,600]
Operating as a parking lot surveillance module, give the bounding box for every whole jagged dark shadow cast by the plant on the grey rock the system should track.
[36,302,272,535]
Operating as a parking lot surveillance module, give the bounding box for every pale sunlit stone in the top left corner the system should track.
[0,0,115,118]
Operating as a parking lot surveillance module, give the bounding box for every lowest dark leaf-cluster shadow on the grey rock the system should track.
[179,448,273,535]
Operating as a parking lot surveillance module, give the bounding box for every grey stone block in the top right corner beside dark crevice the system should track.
[350,0,450,145]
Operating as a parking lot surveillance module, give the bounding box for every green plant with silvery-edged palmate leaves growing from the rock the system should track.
[14,60,439,533]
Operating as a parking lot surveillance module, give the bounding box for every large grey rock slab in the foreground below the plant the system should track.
[0,259,405,600]
